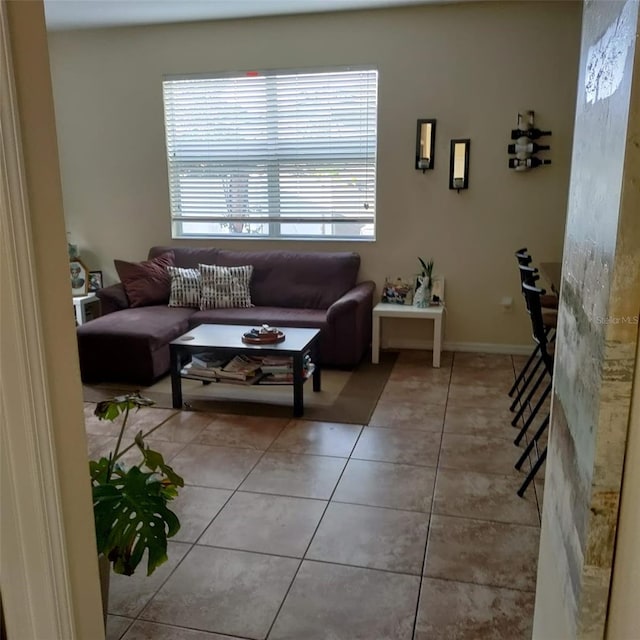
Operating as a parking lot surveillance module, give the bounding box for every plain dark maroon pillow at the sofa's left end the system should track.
[113,251,175,307]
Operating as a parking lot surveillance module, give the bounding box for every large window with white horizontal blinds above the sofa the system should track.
[163,69,378,240]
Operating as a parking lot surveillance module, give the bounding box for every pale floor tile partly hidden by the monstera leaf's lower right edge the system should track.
[169,485,232,542]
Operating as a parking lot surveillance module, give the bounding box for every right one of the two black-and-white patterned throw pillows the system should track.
[198,264,253,310]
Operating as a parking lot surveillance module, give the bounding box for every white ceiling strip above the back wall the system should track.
[44,0,456,31]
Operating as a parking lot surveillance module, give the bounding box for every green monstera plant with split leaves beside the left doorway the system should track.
[89,393,184,576]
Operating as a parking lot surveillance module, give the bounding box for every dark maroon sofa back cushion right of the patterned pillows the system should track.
[215,249,360,309]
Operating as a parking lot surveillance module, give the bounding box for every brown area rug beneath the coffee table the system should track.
[83,352,397,424]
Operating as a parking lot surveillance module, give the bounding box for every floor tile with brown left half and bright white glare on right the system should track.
[269,420,362,458]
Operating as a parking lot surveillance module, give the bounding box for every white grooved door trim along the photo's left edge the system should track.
[0,1,77,640]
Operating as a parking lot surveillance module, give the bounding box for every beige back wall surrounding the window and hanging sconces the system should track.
[50,2,581,344]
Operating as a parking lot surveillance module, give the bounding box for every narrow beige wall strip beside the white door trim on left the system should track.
[2,2,103,639]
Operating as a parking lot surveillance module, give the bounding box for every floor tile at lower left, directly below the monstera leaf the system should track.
[107,541,191,618]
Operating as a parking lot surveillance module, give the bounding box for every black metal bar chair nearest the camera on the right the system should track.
[514,282,554,497]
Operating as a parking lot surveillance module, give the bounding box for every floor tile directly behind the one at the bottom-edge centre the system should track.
[305,503,429,575]
